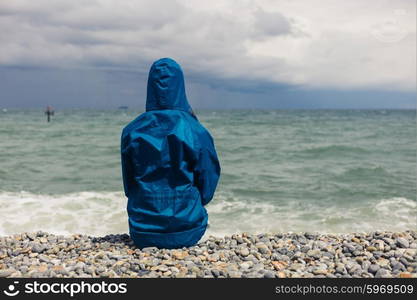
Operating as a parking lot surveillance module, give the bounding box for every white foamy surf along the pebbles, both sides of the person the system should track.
[0,191,417,237]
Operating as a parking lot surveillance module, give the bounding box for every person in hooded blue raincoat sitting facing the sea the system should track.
[121,58,220,248]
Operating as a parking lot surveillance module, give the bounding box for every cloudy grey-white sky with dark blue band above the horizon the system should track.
[0,0,416,109]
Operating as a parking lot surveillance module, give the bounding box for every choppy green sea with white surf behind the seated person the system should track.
[0,109,417,237]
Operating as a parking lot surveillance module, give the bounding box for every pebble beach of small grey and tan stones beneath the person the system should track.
[0,230,417,278]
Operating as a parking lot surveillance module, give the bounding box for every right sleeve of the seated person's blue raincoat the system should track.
[195,137,220,205]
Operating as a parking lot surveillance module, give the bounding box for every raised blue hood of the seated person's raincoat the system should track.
[146,58,192,113]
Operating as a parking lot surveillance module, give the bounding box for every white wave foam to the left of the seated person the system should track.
[0,192,128,235]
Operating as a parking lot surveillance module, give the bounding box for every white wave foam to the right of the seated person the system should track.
[206,194,417,236]
